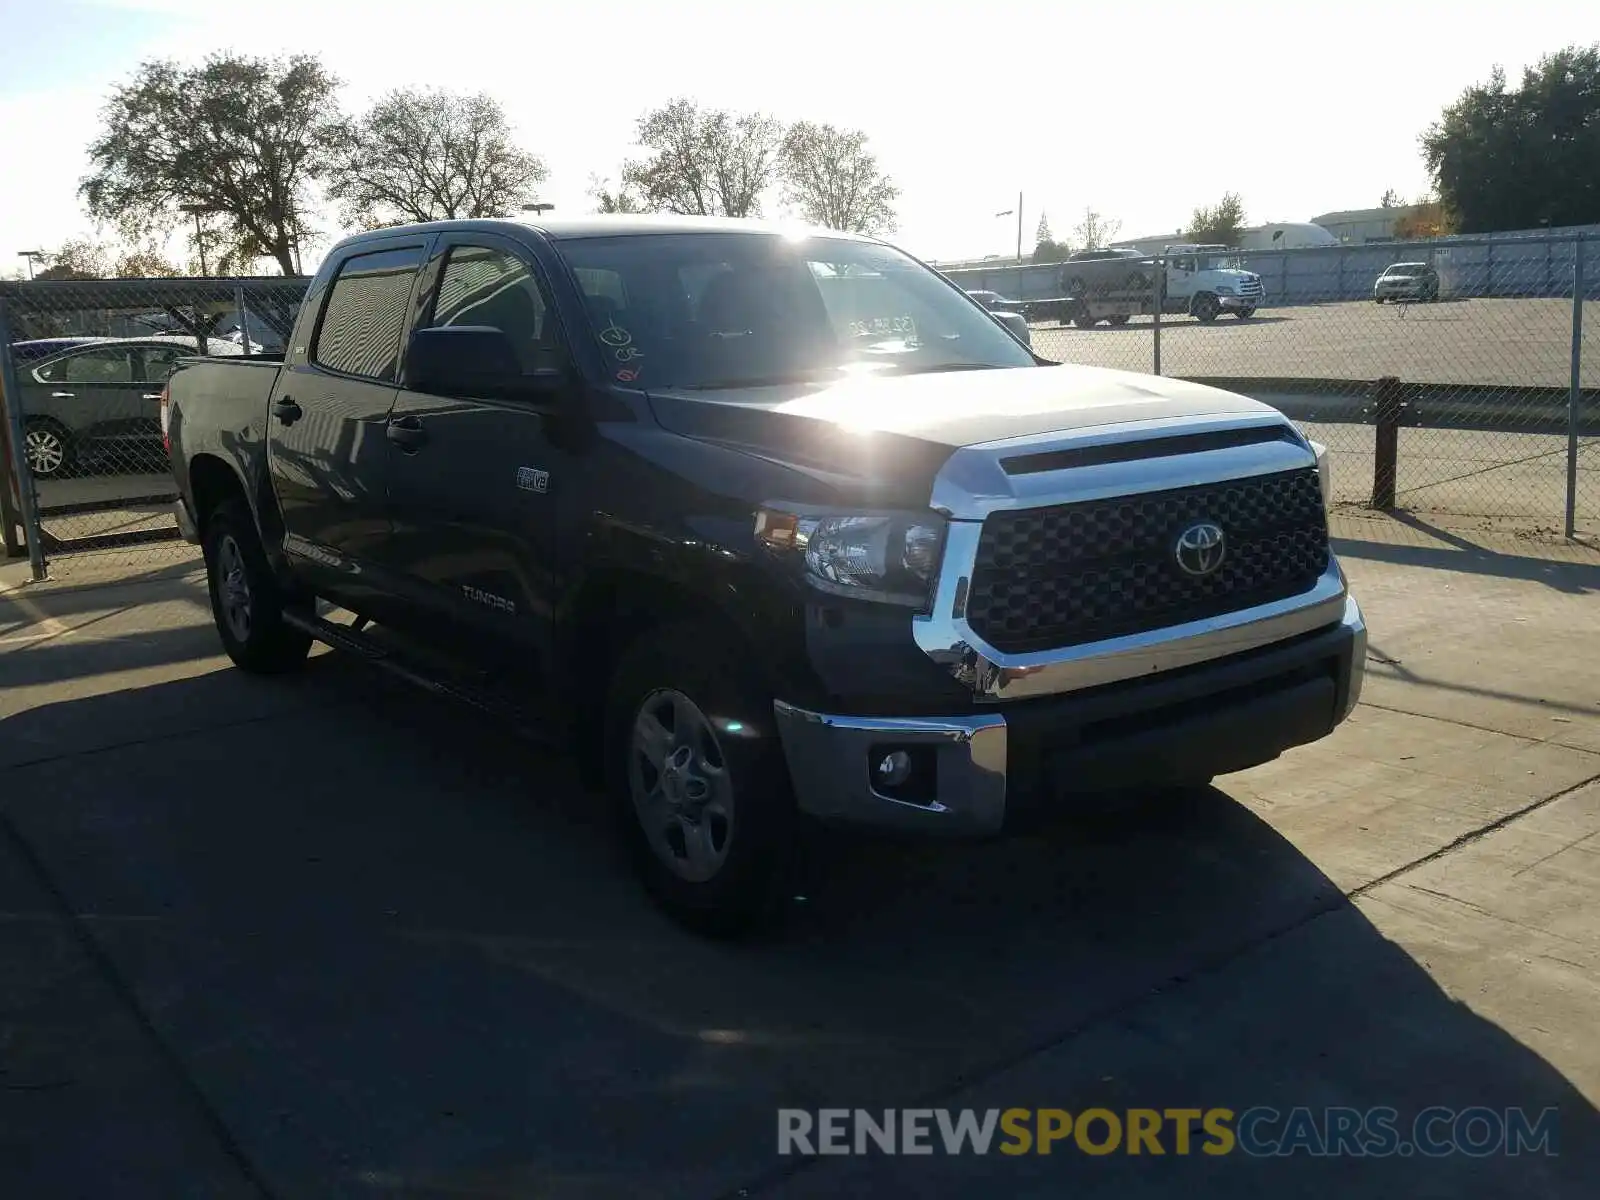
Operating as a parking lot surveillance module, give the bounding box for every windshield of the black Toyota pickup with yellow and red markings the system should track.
[557,234,1037,389]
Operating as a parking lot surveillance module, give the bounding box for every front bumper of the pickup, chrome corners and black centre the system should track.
[774,598,1366,837]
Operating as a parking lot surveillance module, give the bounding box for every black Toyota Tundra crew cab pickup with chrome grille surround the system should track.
[162,216,1366,931]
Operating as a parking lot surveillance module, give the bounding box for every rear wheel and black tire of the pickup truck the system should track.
[202,501,312,675]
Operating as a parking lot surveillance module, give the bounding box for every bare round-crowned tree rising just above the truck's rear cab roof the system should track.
[328,90,549,229]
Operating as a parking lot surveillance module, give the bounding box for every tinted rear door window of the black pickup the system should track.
[312,246,422,382]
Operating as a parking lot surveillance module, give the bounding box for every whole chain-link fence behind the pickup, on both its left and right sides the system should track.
[0,237,1600,579]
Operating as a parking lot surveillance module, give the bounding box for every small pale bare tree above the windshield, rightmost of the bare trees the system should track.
[778,122,899,234]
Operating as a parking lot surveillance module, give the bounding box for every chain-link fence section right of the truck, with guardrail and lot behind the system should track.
[947,237,1600,536]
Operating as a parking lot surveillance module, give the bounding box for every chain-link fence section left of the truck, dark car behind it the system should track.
[0,278,307,560]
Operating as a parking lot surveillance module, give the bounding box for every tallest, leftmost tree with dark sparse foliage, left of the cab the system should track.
[80,54,339,275]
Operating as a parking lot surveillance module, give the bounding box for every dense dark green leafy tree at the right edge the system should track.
[1421,43,1600,234]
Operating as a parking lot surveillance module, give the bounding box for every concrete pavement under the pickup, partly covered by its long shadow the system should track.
[0,517,1600,1200]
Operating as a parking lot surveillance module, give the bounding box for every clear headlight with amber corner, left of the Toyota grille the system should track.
[755,509,946,608]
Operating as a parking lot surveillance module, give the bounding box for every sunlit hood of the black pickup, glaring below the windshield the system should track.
[636,365,1272,456]
